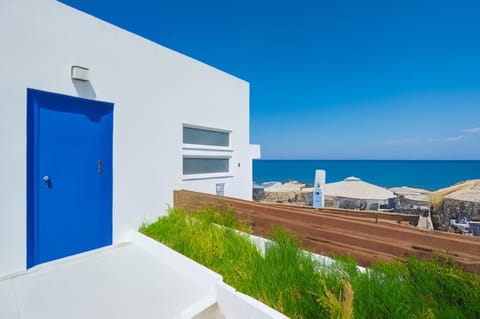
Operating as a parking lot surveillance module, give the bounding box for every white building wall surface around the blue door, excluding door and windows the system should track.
[0,0,255,275]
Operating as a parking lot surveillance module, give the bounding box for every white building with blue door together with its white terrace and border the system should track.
[0,0,280,319]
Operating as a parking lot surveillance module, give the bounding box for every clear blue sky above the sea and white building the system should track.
[62,0,480,160]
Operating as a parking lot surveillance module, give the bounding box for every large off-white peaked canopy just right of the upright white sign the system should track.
[323,176,395,200]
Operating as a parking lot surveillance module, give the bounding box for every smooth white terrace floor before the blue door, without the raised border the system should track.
[0,239,220,319]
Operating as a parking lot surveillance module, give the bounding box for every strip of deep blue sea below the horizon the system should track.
[253,160,480,190]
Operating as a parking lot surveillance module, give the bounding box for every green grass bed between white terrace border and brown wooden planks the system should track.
[140,209,480,319]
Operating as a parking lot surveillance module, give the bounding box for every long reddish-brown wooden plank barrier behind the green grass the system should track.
[174,190,480,273]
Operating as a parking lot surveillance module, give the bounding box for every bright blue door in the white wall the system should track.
[27,89,113,268]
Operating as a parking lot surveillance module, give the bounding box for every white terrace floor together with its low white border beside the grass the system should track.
[0,232,286,319]
